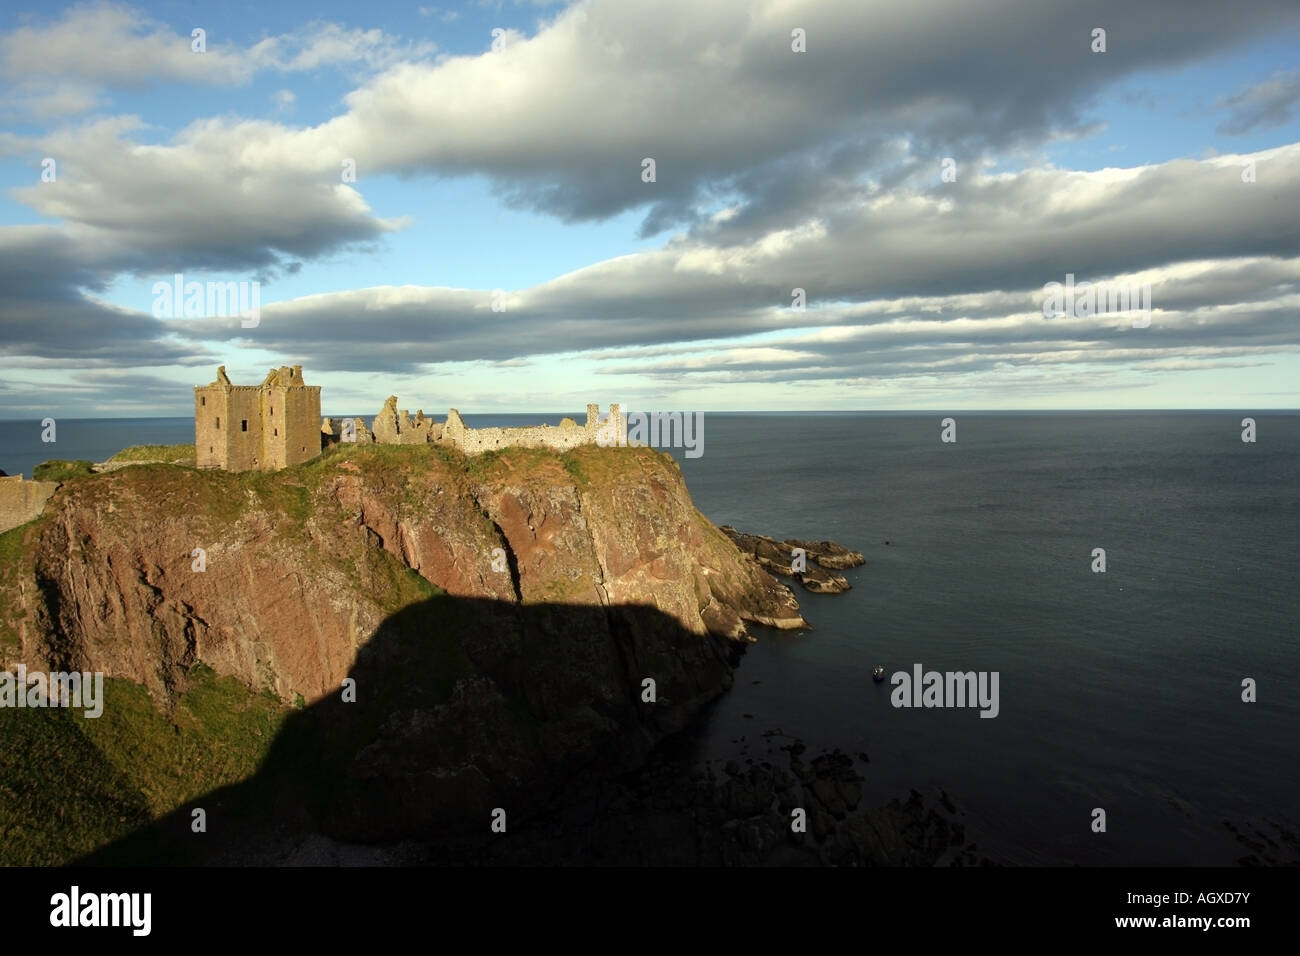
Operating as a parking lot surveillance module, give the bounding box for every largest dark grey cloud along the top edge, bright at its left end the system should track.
[309,0,1300,234]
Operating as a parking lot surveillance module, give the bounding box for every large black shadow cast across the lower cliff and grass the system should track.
[79,596,738,865]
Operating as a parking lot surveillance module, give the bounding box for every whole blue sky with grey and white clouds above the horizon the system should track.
[0,0,1300,419]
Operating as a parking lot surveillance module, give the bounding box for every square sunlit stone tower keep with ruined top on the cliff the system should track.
[194,365,321,471]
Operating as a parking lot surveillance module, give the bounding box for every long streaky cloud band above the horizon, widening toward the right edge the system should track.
[147,146,1300,380]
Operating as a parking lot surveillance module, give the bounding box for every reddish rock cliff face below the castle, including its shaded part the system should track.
[0,446,803,839]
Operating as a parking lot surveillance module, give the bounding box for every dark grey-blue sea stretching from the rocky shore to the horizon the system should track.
[0,410,1300,865]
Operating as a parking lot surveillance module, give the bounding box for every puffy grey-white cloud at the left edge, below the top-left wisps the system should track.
[0,117,403,273]
